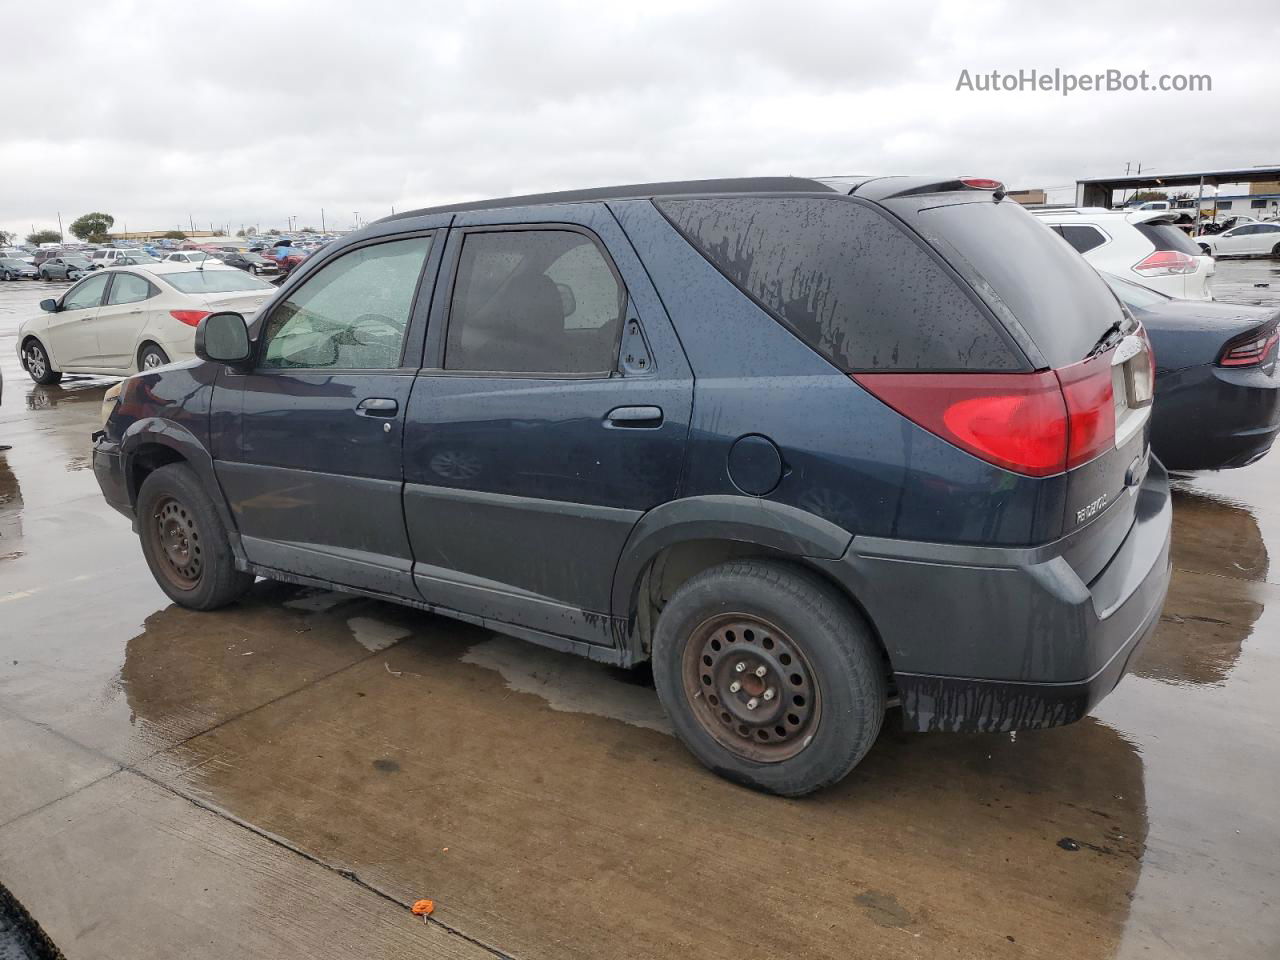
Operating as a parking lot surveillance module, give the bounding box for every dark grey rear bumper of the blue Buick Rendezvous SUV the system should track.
[831,461,1172,731]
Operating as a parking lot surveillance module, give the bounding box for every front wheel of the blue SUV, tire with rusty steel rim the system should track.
[138,463,253,611]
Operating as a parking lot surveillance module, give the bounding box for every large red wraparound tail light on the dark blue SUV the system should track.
[852,353,1116,476]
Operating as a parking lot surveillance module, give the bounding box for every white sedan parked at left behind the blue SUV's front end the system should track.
[18,260,275,384]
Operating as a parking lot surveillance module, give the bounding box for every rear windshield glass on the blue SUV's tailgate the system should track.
[904,200,1124,367]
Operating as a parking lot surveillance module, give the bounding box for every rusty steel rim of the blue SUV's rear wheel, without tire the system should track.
[681,613,822,763]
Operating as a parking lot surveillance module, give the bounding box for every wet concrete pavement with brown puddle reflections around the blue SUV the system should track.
[0,264,1280,960]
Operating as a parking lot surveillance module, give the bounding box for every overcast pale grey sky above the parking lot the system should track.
[0,0,1280,236]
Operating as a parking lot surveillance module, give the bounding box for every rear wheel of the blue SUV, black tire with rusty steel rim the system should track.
[653,561,887,796]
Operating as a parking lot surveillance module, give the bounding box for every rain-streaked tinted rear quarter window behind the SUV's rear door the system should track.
[655,197,1024,372]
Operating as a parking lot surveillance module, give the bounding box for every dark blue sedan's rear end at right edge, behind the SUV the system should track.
[1103,274,1280,470]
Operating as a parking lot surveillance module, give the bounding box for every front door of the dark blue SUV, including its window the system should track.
[212,227,447,598]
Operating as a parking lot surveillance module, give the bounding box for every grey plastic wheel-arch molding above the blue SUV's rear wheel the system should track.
[612,494,854,622]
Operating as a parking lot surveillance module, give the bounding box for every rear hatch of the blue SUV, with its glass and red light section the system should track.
[855,182,1153,582]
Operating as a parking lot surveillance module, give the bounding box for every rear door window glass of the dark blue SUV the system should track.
[444,230,626,375]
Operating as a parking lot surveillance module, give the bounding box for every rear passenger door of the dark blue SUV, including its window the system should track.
[404,204,692,645]
